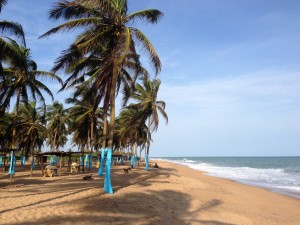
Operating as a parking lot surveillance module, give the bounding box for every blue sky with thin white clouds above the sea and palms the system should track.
[0,0,300,157]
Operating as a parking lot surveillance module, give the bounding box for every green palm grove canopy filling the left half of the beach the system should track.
[0,0,168,192]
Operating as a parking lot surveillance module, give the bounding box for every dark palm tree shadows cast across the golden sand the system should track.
[0,163,238,225]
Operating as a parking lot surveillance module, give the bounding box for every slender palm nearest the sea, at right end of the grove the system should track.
[129,77,168,170]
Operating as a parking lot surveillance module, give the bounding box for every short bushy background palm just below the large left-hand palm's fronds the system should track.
[17,102,48,177]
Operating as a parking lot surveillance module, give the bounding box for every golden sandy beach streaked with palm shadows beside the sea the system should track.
[0,161,300,225]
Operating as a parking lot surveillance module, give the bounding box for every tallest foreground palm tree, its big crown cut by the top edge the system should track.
[42,0,162,192]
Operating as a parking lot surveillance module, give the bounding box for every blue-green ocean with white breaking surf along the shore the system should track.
[156,156,300,198]
